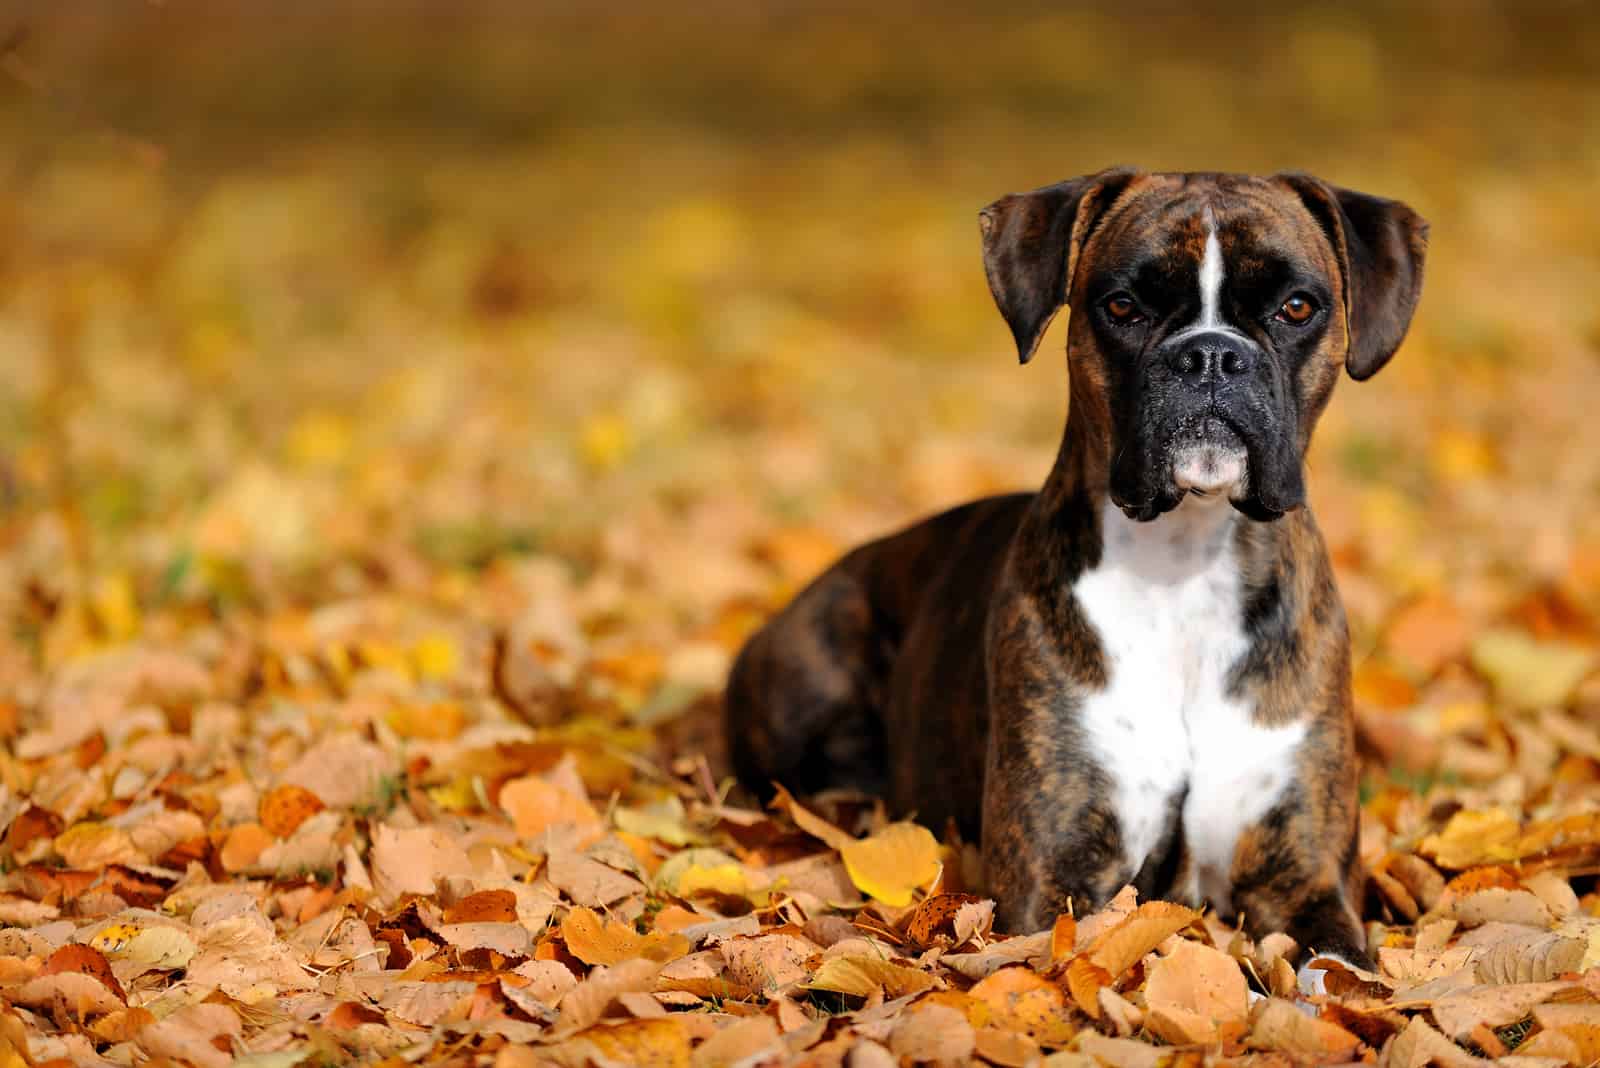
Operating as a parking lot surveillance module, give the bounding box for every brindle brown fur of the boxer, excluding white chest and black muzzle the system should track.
[726,169,1427,962]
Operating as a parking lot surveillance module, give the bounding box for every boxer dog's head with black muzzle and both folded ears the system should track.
[981,169,1427,520]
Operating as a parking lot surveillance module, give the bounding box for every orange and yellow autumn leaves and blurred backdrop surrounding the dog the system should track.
[0,0,1600,1066]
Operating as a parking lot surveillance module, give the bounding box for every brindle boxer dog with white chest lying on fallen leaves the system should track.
[726,169,1427,983]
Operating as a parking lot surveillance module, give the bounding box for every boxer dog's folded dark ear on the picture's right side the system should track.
[1280,174,1427,382]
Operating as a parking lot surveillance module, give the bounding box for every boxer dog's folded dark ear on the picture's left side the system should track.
[978,168,1138,363]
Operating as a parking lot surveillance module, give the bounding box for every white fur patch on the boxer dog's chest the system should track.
[1074,497,1304,913]
